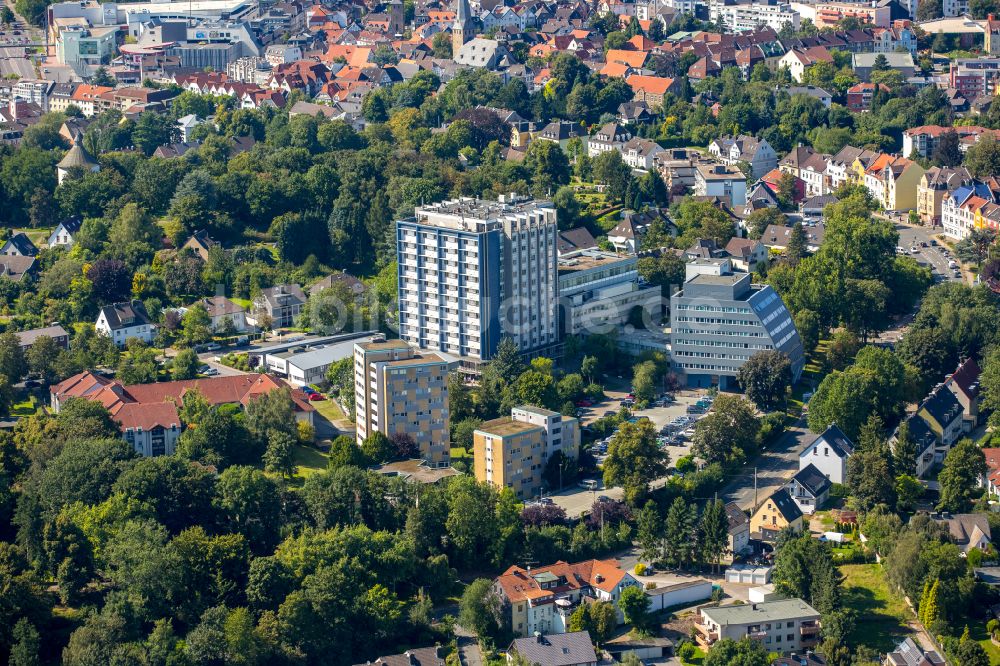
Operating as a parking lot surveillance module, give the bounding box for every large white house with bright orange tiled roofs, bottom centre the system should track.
[493,560,642,636]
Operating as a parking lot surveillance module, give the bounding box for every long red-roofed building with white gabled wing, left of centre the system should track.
[50,370,315,456]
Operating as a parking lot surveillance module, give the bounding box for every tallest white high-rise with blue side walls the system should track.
[396,195,559,375]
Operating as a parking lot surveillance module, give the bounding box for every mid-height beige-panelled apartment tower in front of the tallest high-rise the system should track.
[354,340,451,467]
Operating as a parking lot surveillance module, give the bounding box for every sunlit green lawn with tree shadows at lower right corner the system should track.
[840,564,913,652]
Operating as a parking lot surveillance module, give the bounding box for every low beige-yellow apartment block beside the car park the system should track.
[473,405,580,499]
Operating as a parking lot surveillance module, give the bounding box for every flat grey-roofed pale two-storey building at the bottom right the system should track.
[694,599,820,654]
